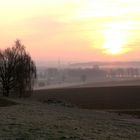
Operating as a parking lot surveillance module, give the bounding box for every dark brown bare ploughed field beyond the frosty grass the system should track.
[33,86,140,109]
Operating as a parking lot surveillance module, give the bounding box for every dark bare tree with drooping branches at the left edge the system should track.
[0,40,36,97]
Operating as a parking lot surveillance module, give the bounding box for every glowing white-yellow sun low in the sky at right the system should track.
[102,23,132,55]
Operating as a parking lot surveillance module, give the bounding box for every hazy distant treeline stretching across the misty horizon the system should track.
[38,68,140,78]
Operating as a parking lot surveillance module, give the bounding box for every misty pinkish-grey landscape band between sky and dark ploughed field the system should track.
[35,61,140,89]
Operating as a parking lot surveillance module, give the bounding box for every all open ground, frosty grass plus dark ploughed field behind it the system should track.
[0,86,140,140]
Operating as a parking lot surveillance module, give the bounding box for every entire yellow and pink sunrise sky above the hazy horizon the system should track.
[0,0,140,62]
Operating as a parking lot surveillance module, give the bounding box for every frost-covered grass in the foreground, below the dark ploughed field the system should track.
[0,100,140,140]
